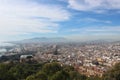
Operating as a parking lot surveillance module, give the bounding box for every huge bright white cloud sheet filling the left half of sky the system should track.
[0,0,70,40]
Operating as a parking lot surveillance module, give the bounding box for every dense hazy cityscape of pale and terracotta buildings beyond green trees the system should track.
[0,41,120,77]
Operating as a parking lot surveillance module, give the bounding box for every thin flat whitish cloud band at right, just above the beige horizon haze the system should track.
[68,26,120,34]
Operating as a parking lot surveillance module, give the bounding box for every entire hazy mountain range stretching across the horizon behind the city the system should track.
[6,37,120,44]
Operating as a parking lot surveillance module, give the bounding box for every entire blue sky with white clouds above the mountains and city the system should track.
[0,0,120,41]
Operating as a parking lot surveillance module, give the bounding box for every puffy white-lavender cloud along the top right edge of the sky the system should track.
[68,0,120,13]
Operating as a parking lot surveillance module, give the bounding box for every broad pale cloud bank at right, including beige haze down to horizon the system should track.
[66,26,120,41]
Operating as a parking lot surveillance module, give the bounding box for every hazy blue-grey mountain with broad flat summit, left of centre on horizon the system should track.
[10,37,68,43]
